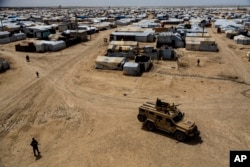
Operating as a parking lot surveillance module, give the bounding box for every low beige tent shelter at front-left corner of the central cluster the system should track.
[95,56,126,70]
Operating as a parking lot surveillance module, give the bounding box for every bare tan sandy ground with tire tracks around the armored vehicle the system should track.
[0,24,250,167]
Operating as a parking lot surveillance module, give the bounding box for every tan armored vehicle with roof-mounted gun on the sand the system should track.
[137,98,200,141]
